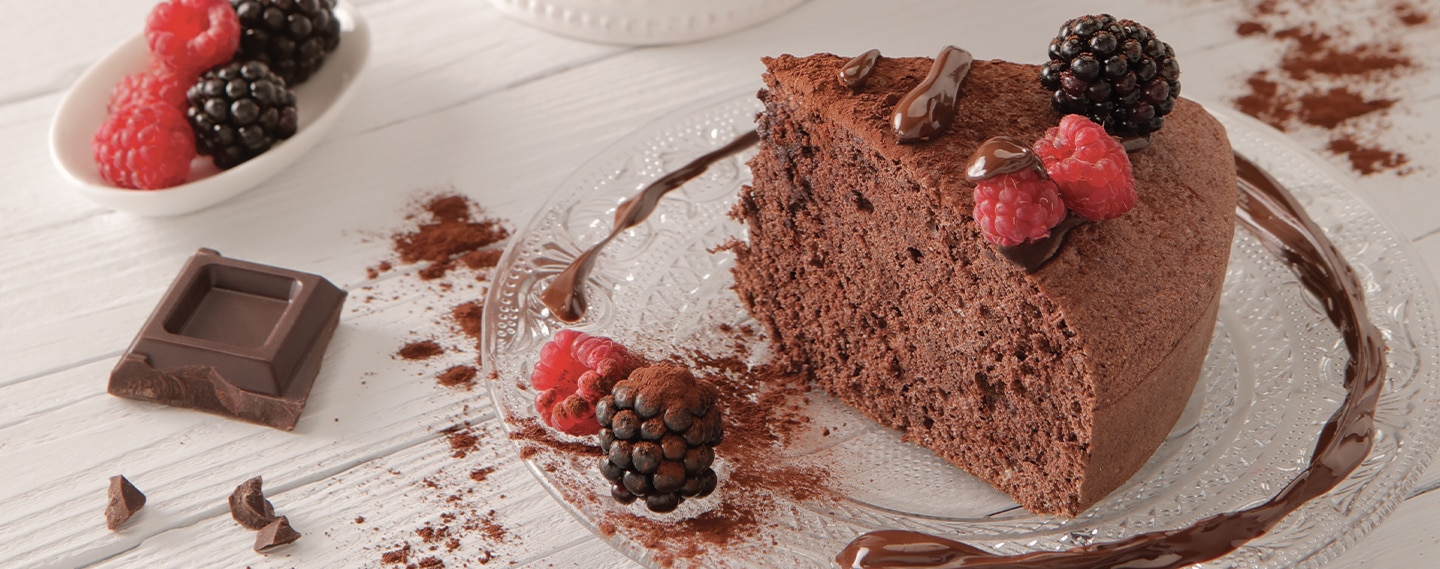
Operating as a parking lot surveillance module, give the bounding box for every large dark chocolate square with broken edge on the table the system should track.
[109,249,346,431]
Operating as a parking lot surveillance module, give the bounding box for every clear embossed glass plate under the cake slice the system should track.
[482,89,1440,568]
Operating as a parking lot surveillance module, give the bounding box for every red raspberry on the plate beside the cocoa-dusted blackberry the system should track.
[530,330,638,435]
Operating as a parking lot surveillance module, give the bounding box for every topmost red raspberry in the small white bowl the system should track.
[145,0,240,78]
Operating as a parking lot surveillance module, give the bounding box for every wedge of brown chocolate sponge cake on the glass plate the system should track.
[732,55,1236,516]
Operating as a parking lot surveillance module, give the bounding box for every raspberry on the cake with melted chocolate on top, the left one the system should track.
[975,169,1066,246]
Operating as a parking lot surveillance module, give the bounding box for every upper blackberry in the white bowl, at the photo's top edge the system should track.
[230,0,340,86]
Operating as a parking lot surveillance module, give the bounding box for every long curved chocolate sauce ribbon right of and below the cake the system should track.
[835,154,1387,569]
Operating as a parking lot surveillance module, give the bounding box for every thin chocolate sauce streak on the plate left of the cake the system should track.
[540,131,760,323]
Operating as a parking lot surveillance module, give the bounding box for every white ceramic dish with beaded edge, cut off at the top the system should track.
[490,0,805,45]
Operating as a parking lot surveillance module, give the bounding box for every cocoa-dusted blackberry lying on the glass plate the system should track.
[595,363,724,513]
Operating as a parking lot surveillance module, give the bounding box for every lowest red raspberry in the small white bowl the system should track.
[91,101,194,190]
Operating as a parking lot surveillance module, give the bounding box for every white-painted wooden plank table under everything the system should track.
[0,0,1440,568]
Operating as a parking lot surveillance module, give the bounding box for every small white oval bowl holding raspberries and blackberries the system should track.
[50,1,370,216]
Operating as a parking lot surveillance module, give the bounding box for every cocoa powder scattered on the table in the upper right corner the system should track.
[1234,0,1430,176]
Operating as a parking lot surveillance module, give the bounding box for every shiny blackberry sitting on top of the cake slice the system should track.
[1040,14,1179,137]
